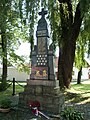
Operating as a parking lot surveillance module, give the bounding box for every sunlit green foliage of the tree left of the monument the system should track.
[0,1,29,70]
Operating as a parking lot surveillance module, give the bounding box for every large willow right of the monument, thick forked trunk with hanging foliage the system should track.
[47,0,90,88]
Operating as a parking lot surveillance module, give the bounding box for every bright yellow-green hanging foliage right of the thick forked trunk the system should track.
[75,12,90,69]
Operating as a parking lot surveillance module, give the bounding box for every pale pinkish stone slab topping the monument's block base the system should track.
[27,79,59,87]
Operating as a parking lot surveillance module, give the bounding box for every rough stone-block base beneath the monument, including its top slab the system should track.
[19,79,64,114]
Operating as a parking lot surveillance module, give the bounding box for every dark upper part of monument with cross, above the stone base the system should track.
[30,8,55,80]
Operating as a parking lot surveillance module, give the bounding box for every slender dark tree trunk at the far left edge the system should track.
[0,1,11,87]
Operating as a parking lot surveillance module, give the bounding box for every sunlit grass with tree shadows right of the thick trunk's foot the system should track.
[65,84,90,104]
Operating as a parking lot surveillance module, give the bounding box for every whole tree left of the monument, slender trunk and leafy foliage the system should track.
[0,0,36,90]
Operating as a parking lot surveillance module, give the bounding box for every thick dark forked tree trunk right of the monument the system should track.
[58,0,83,88]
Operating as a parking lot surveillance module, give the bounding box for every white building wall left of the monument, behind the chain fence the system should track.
[0,67,30,81]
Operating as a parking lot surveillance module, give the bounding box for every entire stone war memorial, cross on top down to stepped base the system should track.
[19,9,64,114]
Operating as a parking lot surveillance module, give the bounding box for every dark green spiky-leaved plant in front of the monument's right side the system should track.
[61,108,84,120]
